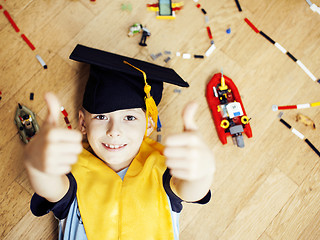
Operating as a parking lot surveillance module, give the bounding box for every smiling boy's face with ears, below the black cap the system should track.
[79,108,153,172]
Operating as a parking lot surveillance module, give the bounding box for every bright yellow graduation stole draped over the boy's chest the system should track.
[72,138,174,240]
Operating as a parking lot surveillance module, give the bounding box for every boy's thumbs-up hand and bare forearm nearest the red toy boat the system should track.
[164,102,215,201]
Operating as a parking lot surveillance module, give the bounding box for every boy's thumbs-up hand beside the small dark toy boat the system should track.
[24,93,82,175]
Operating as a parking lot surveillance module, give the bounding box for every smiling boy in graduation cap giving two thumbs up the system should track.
[25,45,215,240]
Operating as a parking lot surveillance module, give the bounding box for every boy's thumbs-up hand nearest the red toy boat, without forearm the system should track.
[164,102,216,181]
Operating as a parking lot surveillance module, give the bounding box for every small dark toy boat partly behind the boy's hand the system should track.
[14,103,39,144]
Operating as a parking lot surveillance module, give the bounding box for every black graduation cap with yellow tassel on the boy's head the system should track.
[69,44,189,131]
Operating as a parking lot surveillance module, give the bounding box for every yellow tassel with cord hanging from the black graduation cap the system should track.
[123,61,158,133]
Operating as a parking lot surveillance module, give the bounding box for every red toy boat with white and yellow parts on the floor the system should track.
[206,73,252,148]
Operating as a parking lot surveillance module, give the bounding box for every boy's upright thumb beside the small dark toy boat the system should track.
[44,92,61,126]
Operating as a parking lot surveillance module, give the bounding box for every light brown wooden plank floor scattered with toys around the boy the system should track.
[0,0,320,240]
